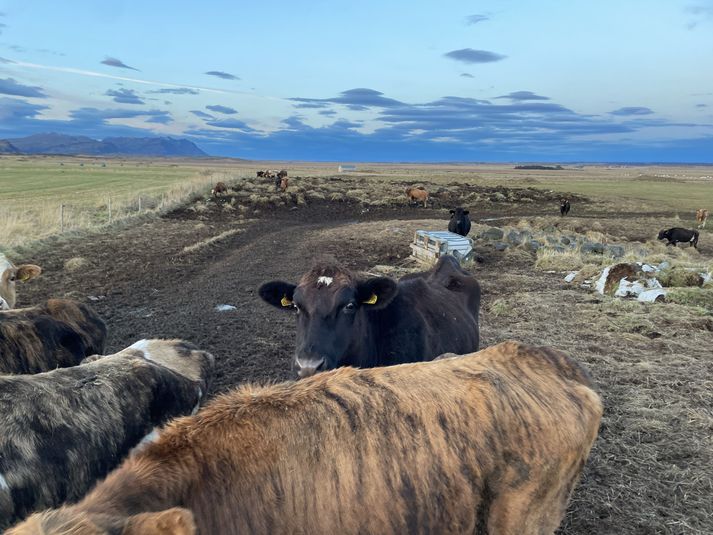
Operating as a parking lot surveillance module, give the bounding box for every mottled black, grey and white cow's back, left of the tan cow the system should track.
[0,340,213,529]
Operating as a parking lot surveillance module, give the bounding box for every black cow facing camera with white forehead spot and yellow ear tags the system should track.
[258,256,480,377]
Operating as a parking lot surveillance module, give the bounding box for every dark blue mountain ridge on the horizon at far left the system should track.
[0,133,208,157]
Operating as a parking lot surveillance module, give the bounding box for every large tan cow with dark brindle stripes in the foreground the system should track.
[8,342,602,535]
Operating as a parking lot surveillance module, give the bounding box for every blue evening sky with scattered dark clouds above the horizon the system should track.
[0,0,713,163]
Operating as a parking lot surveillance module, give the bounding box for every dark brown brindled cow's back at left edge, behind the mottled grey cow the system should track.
[0,299,106,374]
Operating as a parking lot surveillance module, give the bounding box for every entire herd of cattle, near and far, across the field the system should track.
[0,179,707,535]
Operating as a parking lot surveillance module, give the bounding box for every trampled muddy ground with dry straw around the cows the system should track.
[17,181,713,534]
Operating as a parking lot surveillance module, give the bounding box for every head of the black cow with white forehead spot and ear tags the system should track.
[259,264,398,377]
